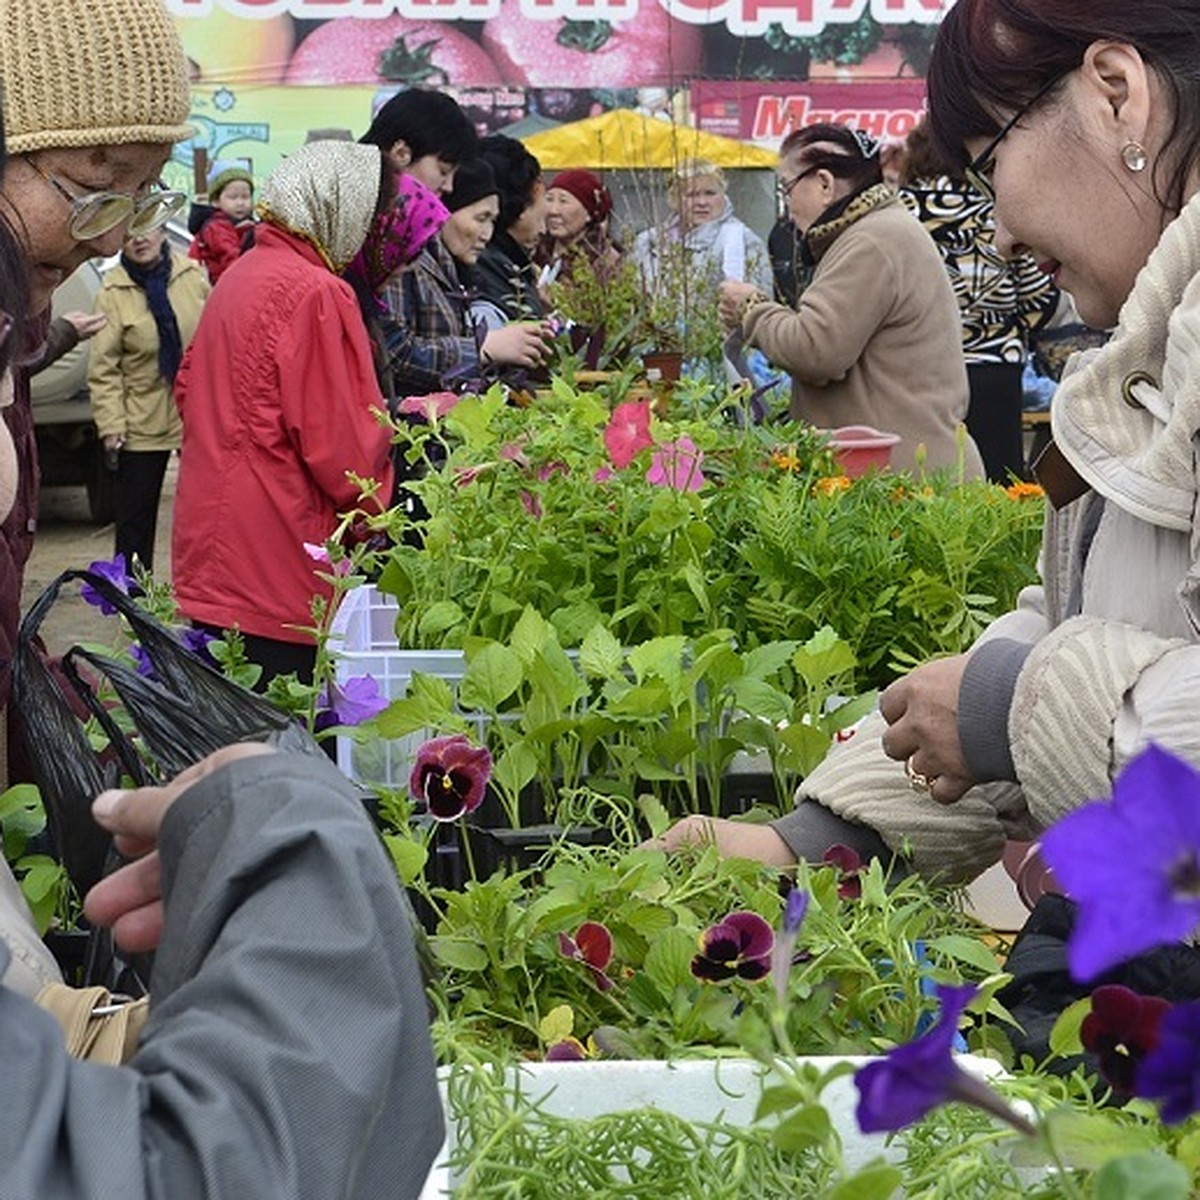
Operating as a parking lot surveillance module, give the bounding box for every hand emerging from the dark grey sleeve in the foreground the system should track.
[83,742,275,954]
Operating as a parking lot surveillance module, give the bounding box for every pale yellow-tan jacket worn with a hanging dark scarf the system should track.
[88,253,210,450]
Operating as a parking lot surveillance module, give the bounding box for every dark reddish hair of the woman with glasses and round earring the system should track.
[928,0,1200,212]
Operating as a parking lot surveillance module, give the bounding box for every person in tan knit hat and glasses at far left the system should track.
[0,0,192,774]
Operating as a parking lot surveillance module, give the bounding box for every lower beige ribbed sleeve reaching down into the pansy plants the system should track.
[796,713,1026,882]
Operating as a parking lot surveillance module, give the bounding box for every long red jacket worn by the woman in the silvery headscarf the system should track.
[172,224,392,643]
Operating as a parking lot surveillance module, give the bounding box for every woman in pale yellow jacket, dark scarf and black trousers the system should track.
[88,229,209,571]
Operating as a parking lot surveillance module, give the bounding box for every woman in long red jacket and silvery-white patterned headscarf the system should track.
[172,142,403,685]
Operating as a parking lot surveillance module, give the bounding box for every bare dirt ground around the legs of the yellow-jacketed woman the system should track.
[20,458,179,654]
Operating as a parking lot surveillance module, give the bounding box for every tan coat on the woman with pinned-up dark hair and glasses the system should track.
[743,193,983,479]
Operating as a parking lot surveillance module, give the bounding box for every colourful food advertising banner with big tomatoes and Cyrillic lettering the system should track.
[164,0,953,187]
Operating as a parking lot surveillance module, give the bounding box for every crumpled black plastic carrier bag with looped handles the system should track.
[13,571,323,895]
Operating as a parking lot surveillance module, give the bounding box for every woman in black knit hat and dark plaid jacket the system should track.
[383,158,548,397]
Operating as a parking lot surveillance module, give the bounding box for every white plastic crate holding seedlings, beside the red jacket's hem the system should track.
[332,583,484,787]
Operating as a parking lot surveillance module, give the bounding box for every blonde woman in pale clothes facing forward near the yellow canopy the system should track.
[634,158,772,292]
